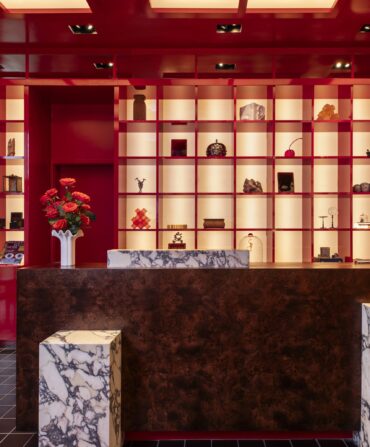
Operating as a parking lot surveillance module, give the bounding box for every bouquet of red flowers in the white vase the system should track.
[40,178,95,234]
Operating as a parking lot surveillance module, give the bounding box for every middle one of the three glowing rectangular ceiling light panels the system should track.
[149,0,239,11]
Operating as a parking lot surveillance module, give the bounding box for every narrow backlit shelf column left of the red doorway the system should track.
[0,85,25,262]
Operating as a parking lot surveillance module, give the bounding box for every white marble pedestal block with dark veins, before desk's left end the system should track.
[39,331,122,447]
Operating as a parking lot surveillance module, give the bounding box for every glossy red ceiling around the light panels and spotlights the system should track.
[0,0,370,77]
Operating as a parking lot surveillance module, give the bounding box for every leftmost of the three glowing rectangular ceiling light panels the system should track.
[0,0,91,13]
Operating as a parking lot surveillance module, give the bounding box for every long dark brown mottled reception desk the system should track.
[17,264,370,432]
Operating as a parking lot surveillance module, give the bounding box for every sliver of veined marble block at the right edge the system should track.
[360,304,370,447]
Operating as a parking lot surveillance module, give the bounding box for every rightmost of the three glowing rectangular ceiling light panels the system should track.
[247,0,338,11]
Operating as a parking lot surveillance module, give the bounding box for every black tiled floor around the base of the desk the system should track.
[0,344,355,447]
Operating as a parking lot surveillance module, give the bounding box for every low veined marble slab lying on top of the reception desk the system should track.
[107,250,249,269]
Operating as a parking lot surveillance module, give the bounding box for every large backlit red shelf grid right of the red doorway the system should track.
[117,85,370,262]
